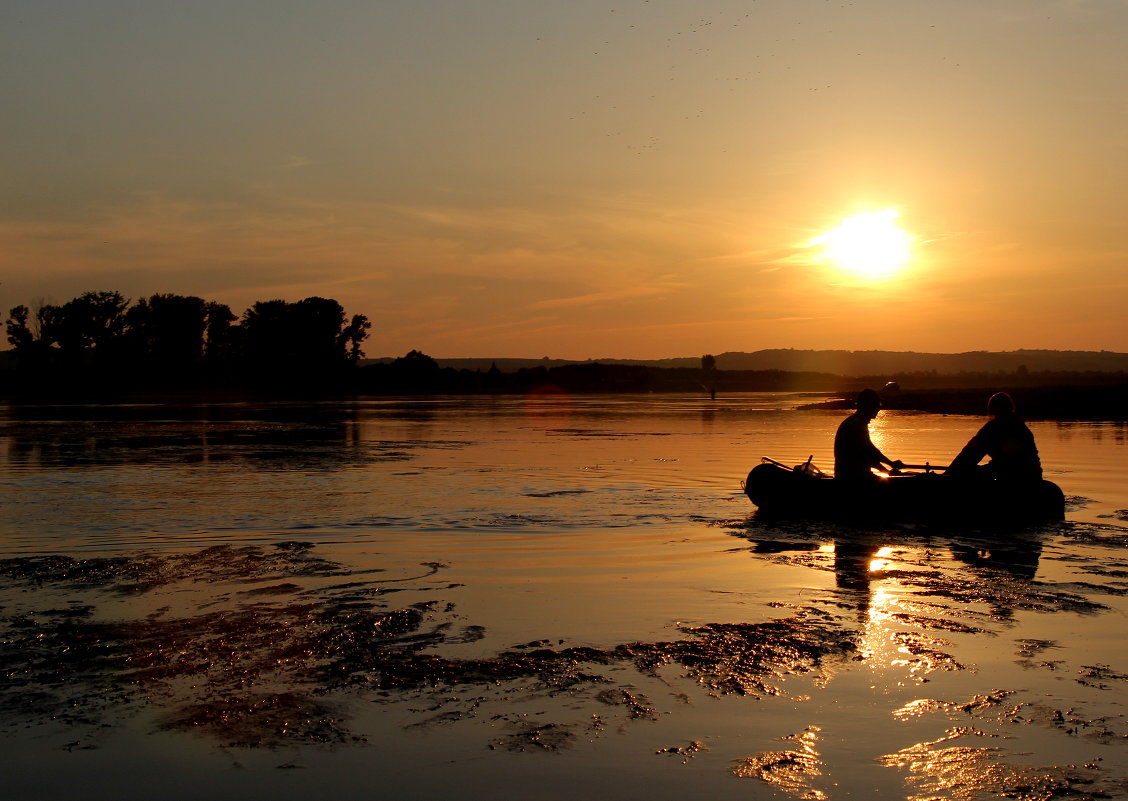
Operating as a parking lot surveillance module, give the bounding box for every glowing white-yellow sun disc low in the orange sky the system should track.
[810,209,913,281]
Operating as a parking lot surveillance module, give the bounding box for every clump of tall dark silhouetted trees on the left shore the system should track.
[5,292,371,394]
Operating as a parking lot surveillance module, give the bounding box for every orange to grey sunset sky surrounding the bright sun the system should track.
[0,0,1128,359]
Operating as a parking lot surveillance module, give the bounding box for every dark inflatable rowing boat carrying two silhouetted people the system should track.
[743,459,1065,523]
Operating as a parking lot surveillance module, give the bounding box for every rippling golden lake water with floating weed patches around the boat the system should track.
[0,394,1128,800]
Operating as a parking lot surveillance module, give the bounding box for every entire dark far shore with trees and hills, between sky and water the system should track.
[0,291,1128,420]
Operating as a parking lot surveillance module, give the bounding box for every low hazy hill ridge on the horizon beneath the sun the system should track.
[421,349,1128,377]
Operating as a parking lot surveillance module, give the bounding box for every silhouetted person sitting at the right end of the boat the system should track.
[946,393,1042,481]
